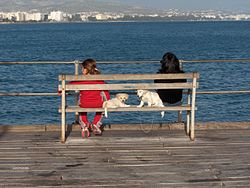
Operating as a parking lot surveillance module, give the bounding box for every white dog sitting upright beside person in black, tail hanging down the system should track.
[137,89,164,118]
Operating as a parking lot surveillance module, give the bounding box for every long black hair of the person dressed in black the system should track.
[159,52,181,73]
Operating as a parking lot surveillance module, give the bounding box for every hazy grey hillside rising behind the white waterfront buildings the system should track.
[0,0,146,13]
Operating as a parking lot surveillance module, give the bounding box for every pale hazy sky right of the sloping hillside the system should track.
[119,0,250,12]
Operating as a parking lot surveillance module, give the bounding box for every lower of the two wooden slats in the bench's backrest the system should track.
[59,83,193,91]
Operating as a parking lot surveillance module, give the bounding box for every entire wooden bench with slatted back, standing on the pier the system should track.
[59,72,199,143]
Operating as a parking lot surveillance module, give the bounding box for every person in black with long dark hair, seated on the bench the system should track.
[154,52,187,104]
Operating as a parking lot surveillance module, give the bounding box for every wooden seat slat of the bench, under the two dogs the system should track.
[58,105,191,113]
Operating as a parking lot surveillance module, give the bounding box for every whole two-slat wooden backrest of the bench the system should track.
[59,72,199,91]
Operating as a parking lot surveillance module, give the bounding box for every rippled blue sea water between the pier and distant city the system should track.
[0,22,250,125]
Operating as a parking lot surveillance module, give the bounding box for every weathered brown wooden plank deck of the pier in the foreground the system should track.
[0,123,250,188]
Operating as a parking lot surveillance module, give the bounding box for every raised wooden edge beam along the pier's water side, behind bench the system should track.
[0,122,250,134]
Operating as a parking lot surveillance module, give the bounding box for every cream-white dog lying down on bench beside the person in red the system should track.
[102,93,130,117]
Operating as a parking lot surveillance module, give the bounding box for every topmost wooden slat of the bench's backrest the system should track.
[59,72,199,81]
